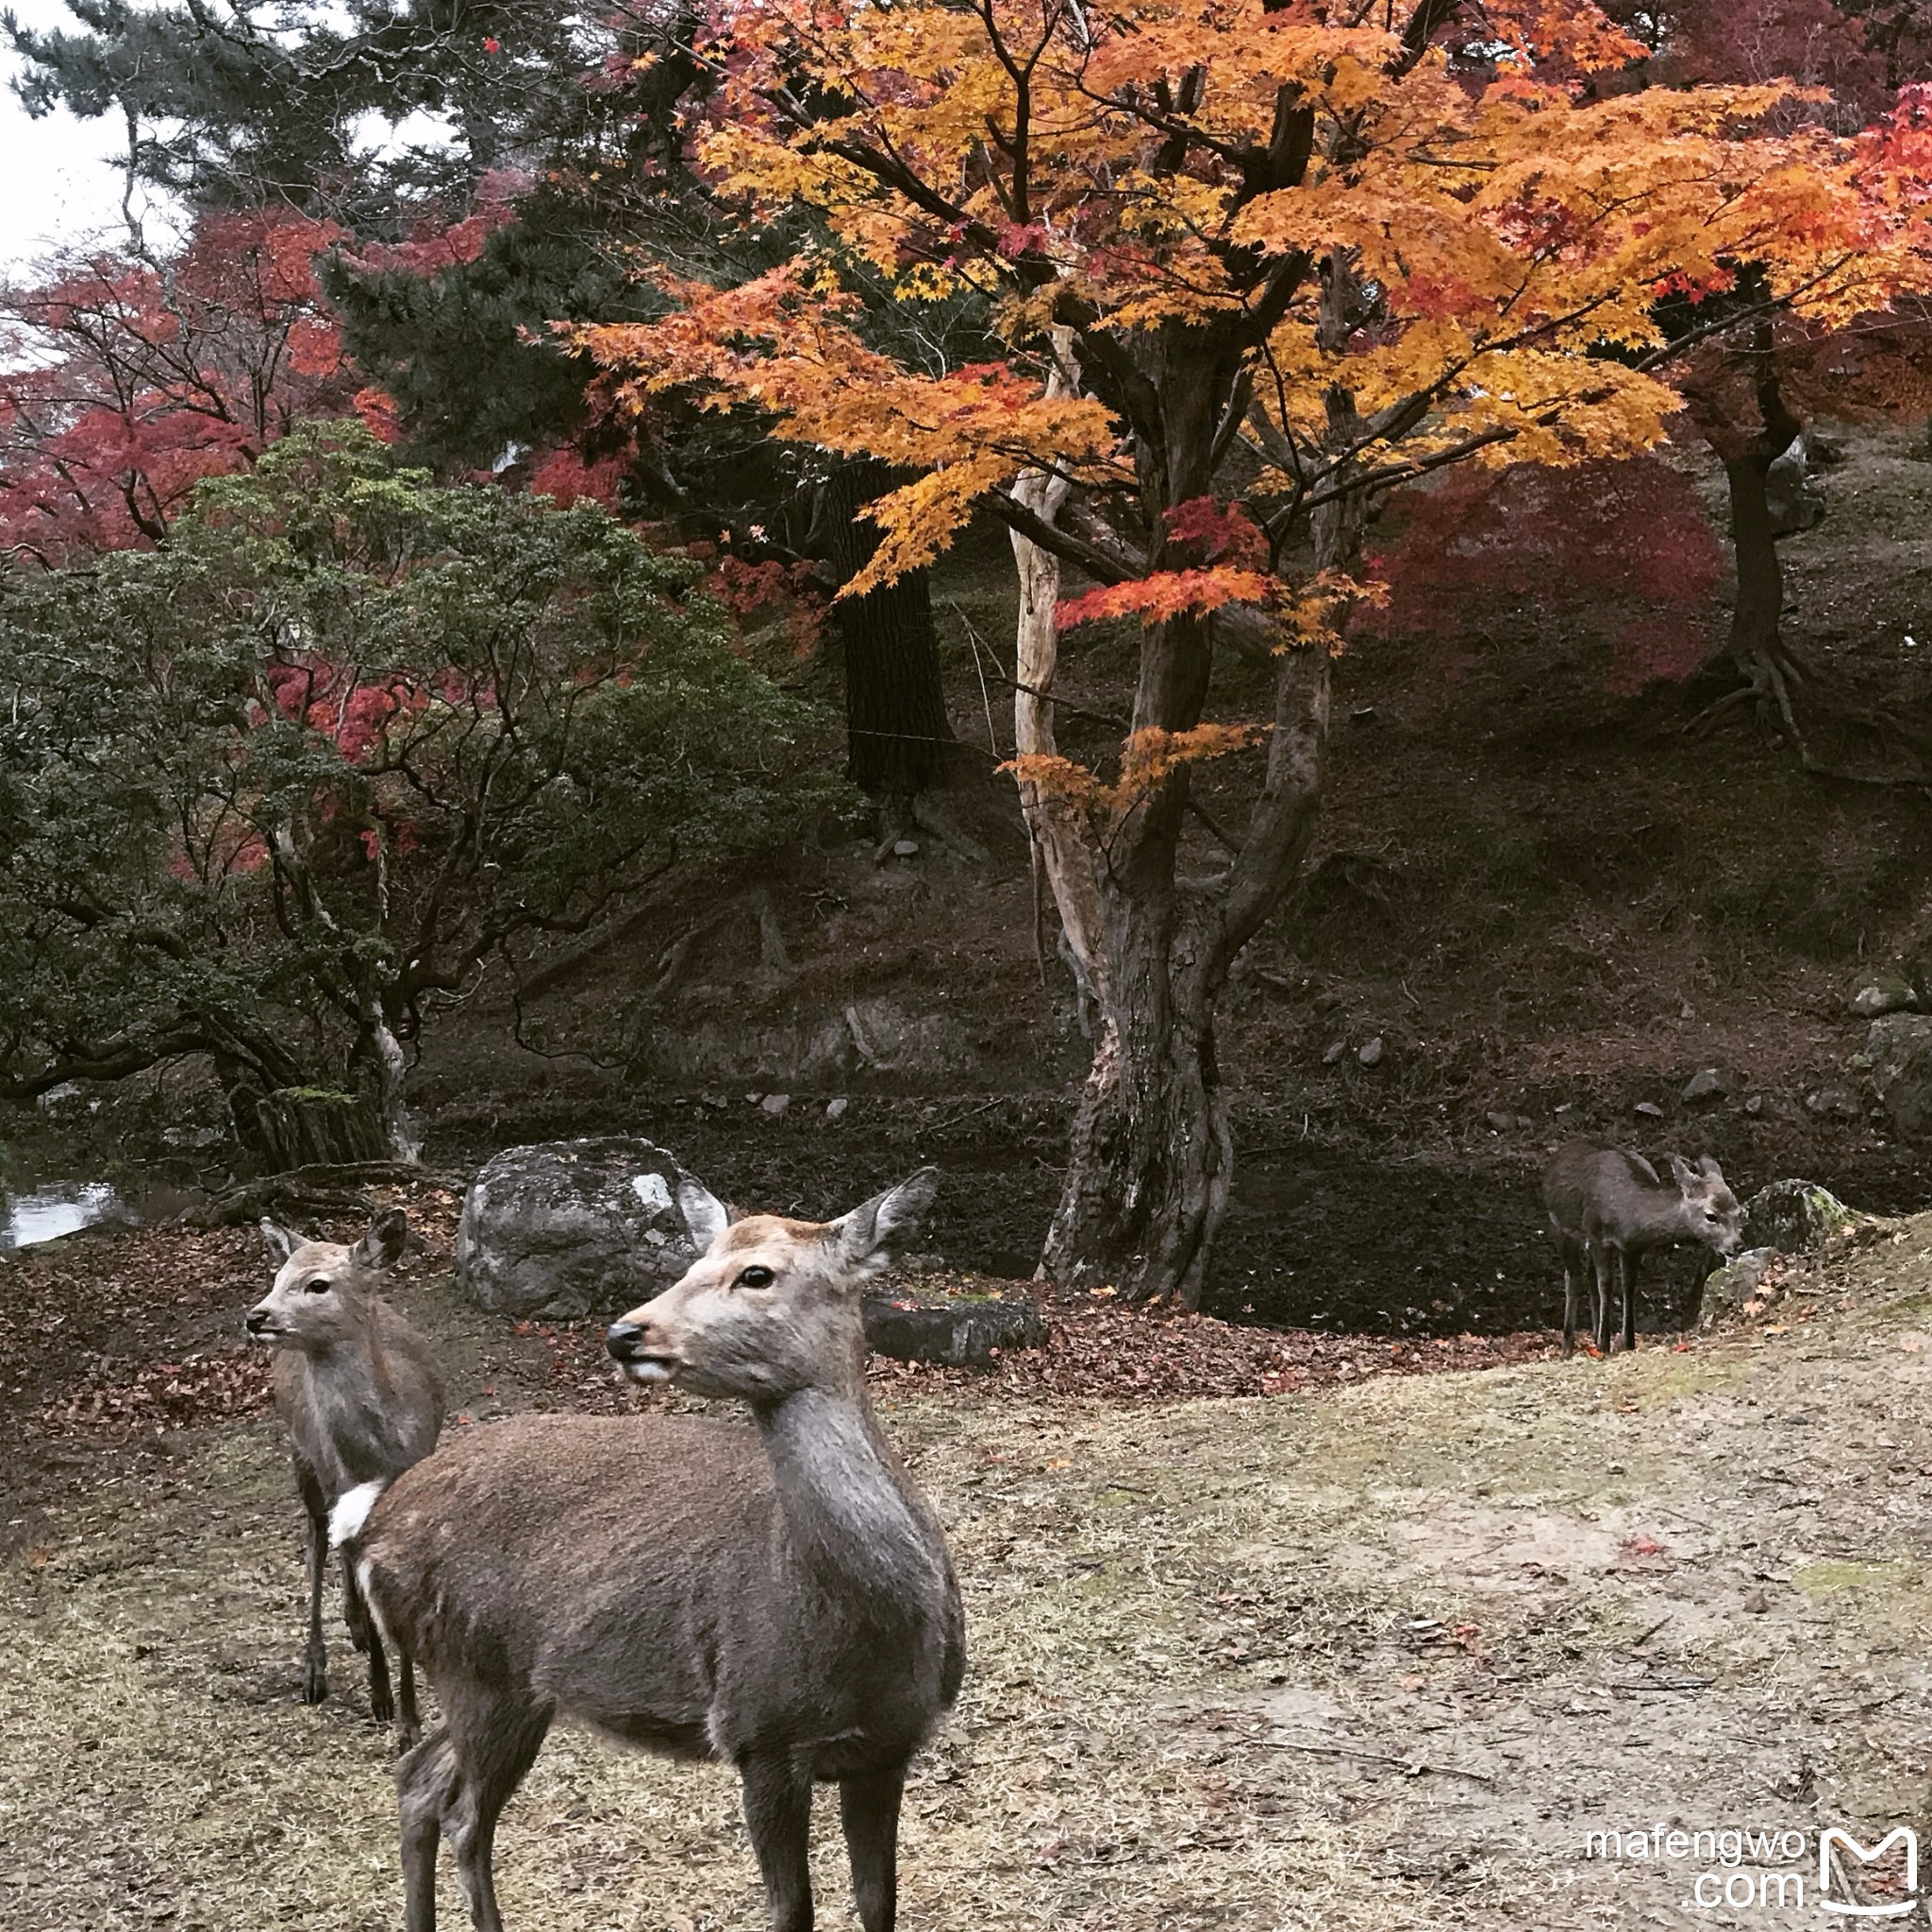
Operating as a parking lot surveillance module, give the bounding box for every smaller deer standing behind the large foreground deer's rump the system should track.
[245,1209,442,1744]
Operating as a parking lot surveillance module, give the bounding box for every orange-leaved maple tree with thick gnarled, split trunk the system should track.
[577,0,1917,1304]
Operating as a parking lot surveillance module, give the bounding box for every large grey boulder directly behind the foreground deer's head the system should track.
[456,1136,714,1322]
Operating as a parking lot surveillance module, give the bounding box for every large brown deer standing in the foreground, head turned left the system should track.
[330,1169,966,1932]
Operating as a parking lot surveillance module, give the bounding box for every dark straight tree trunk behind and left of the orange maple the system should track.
[821,461,957,799]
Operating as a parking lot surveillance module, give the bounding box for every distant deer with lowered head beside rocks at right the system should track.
[1543,1140,1744,1355]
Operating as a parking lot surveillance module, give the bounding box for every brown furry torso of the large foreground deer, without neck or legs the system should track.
[358,1416,957,1757]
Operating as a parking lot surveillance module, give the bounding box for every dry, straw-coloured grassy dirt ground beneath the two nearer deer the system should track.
[0,1217,1932,1932]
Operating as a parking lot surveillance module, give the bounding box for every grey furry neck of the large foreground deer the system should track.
[758,1390,947,1611]
